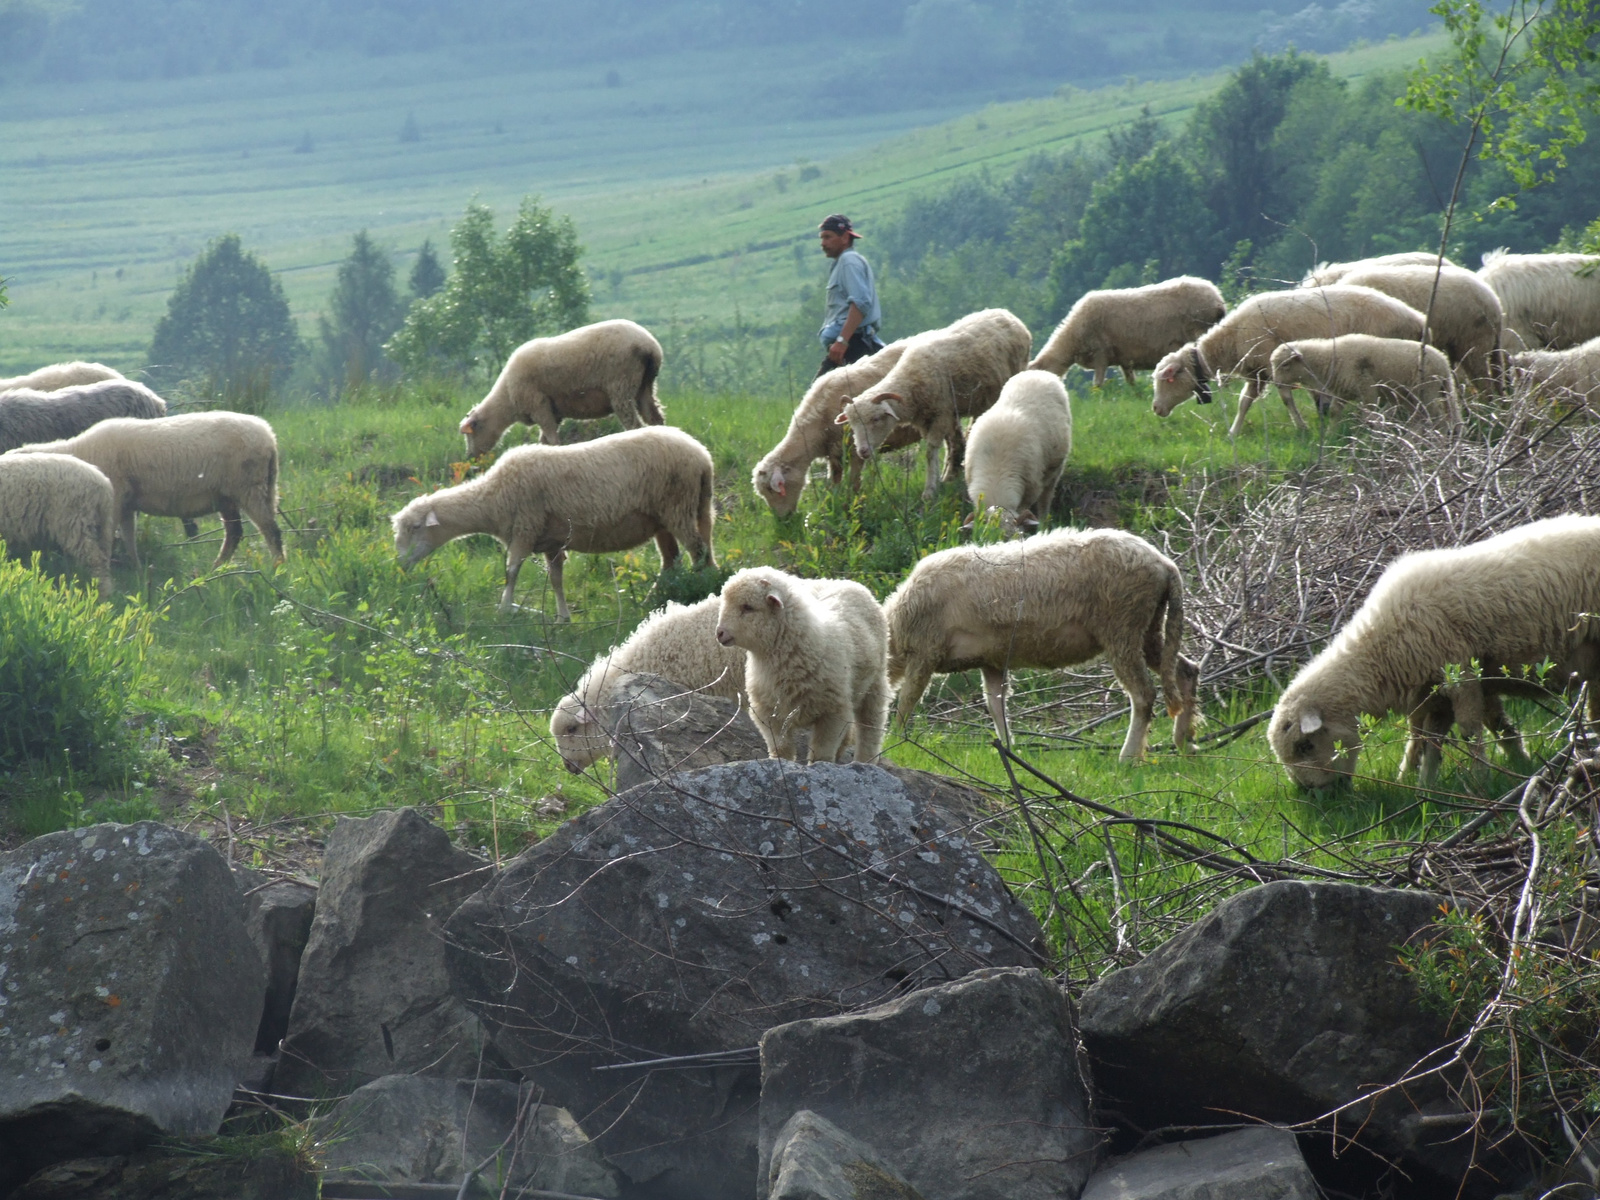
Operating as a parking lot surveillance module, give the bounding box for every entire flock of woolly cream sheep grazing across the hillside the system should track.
[0,253,1600,786]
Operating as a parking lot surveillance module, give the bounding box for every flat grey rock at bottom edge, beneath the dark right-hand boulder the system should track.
[1083,1126,1322,1200]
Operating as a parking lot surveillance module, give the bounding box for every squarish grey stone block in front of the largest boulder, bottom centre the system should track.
[758,968,1099,1200]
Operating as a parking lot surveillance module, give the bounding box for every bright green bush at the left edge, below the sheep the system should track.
[0,555,152,776]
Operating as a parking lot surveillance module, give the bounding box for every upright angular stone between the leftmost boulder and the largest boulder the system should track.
[272,808,493,1096]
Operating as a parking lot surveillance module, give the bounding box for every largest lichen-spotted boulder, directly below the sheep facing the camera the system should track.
[446,758,1045,1200]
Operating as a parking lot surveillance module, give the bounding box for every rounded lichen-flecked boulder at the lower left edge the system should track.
[0,821,266,1194]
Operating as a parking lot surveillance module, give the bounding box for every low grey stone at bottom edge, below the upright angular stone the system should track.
[318,1075,621,1200]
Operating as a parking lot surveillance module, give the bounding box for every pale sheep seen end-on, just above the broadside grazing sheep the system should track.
[966,371,1072,538]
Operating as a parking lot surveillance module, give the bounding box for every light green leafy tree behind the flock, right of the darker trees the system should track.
[384,197,589,373]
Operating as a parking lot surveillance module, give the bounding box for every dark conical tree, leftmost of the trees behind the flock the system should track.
[150,234,301,384]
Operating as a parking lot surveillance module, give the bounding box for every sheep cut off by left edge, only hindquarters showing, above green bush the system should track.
[0,454,117,600]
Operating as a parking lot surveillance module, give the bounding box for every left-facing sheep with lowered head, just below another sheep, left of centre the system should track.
[390,426,717,621]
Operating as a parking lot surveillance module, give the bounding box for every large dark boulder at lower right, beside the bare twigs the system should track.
[1080,882,1472,1181]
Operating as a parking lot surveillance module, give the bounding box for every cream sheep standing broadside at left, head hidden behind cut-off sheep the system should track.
[11,413,283,570]
